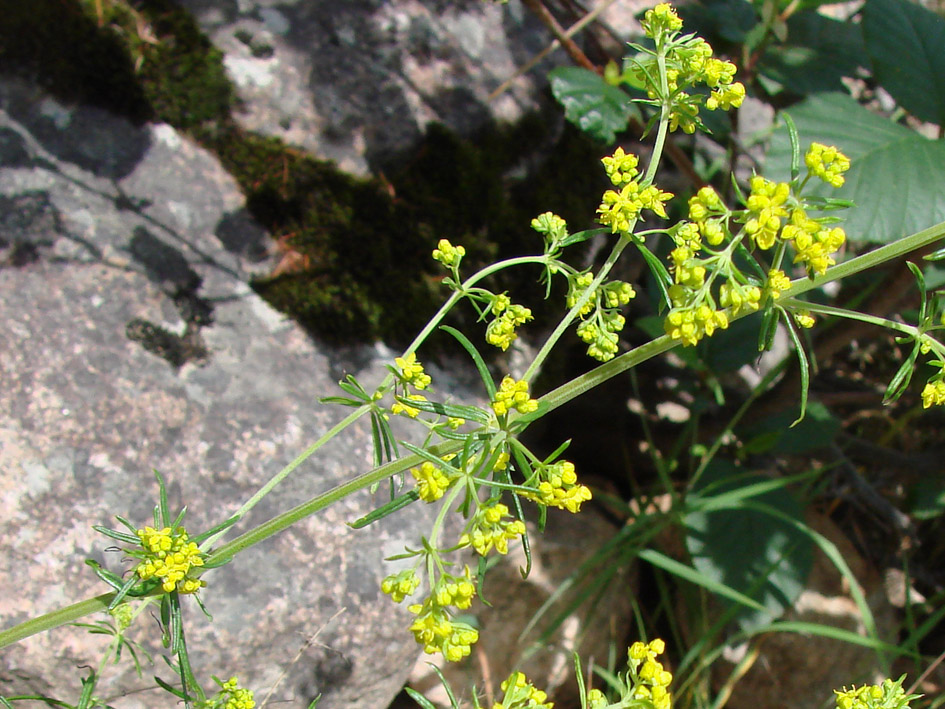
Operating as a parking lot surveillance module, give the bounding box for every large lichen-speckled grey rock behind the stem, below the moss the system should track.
[0,76,458,709]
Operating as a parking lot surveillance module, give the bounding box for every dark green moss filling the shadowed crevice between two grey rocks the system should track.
[0,0,604,345]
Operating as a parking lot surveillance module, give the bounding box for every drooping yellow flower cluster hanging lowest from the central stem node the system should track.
[407,567,479,662]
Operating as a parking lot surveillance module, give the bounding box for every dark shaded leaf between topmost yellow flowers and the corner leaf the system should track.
[759,11,869,95]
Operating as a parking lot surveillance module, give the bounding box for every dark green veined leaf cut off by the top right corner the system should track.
[863,0,945,125]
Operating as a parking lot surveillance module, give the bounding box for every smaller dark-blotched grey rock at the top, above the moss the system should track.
[173,0,568,175]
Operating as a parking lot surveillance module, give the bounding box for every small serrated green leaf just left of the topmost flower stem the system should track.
[548,67,640,144]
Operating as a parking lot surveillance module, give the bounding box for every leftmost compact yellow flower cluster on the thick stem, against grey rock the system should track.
[135,527,207,593]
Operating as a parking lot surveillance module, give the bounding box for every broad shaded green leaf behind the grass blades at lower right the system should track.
[683,459,813,631]
